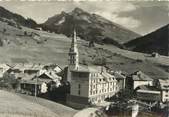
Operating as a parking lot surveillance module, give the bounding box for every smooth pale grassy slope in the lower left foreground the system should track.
[0,90,76,117]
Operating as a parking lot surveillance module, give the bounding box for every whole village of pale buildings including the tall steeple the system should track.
[0,30,169,117]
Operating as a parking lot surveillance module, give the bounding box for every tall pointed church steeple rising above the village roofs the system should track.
[69,30,79,69]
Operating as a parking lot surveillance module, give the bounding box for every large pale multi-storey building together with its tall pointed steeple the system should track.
[67,31,119,108]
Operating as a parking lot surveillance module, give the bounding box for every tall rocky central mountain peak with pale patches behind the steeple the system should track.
[42,8,139,47]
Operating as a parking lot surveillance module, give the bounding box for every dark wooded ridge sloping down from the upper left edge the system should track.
[0,6,37,28]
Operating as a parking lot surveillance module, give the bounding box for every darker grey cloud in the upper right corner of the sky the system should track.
[118,2,169,35]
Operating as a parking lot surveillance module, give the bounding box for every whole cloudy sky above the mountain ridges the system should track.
[0,0,169,35]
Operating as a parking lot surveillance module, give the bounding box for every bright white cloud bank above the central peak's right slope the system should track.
[74,1,141,29]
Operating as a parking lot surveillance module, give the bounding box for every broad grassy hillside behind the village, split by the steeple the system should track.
[0,22,169,78]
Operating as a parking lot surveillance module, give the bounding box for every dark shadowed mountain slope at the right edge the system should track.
[125,24,169,56]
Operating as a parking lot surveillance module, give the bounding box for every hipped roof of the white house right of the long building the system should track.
[131,71,153,81]
